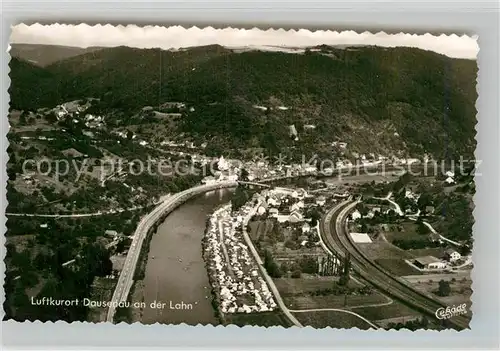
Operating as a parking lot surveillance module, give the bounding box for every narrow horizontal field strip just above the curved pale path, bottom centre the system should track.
[283,293,388,310]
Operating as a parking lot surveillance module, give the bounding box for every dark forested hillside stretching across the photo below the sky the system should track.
[10,45,477,157]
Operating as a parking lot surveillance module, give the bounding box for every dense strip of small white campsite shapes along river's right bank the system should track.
[205,204,277,313]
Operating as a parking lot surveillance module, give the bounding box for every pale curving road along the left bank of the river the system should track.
[106,182,238,322]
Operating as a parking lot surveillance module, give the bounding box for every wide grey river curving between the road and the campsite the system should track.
[141,189,231,325]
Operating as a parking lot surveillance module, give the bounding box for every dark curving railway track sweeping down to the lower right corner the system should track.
[321,202,470,330]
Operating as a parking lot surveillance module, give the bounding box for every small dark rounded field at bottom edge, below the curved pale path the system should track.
[293,311,371,329]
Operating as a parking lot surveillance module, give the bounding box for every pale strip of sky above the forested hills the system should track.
[11,23,479,59]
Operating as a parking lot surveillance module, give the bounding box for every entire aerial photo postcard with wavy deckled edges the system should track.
[3,24,481,331]
